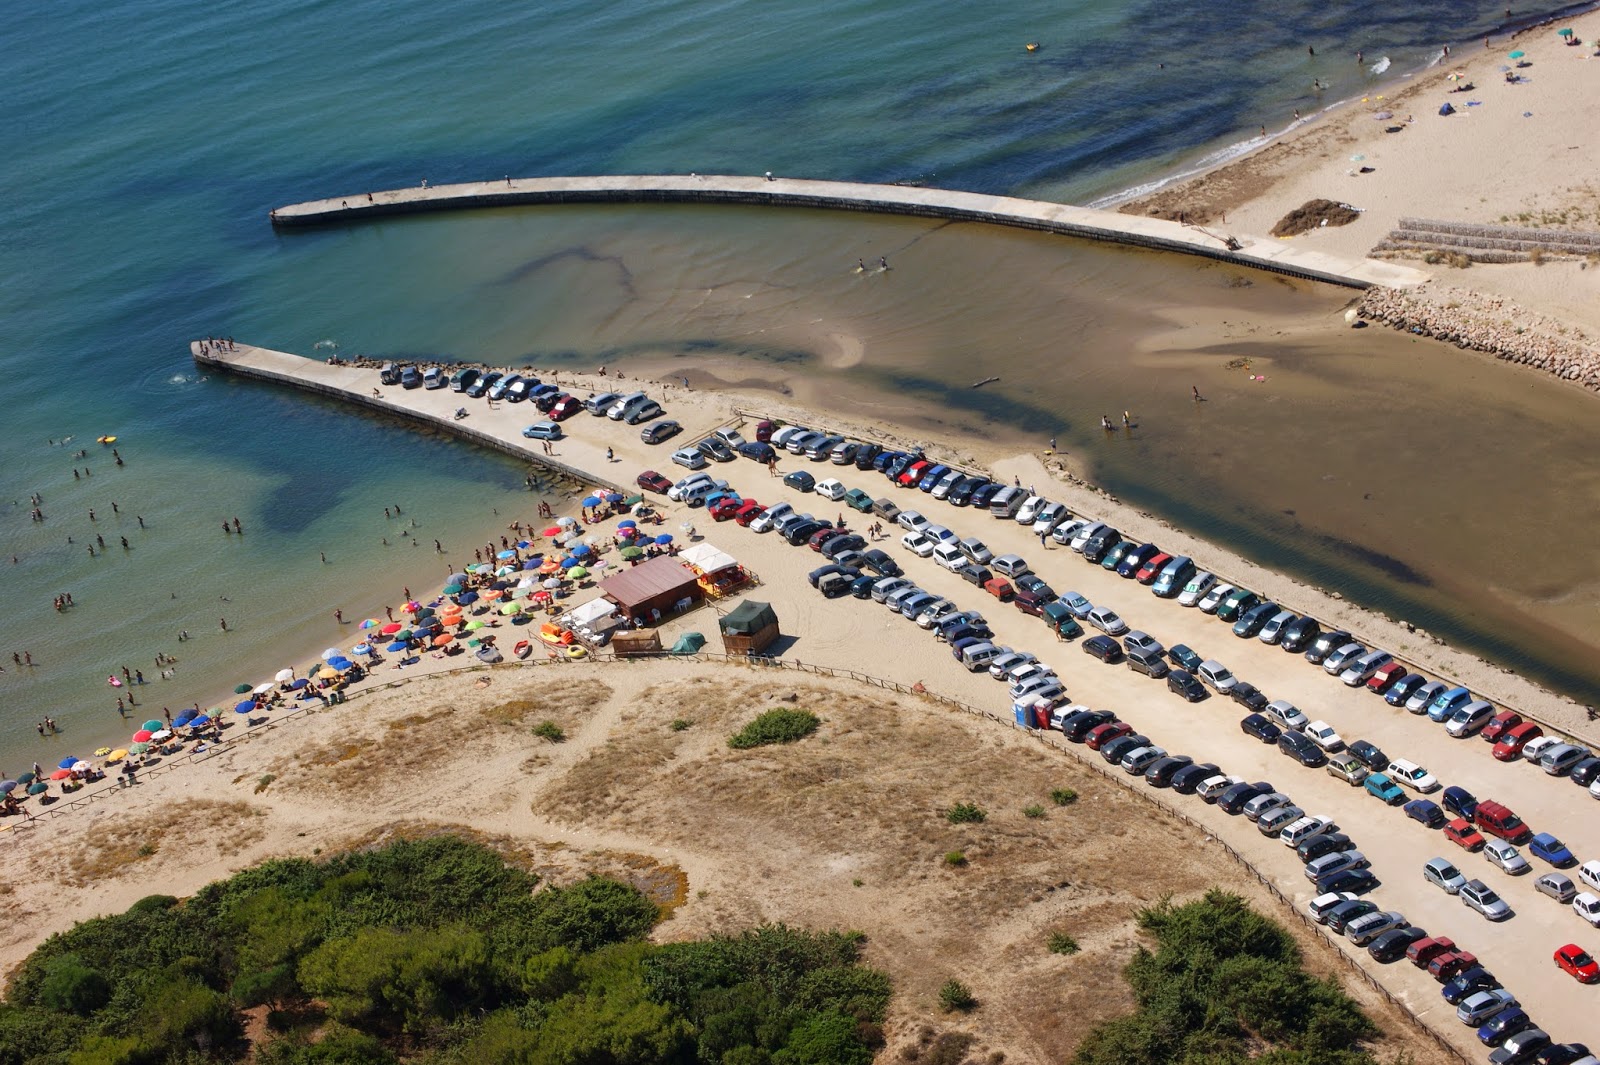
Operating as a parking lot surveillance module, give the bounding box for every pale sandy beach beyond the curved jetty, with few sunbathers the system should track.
[1120,11,1600,347]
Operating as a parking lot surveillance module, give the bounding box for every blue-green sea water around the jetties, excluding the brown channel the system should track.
[0,0,1561,772]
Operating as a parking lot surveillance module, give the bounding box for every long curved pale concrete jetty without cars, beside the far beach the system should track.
[272,174,1429,288]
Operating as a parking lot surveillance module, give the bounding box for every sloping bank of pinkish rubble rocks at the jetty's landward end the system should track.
[1357,286,1600,392]
